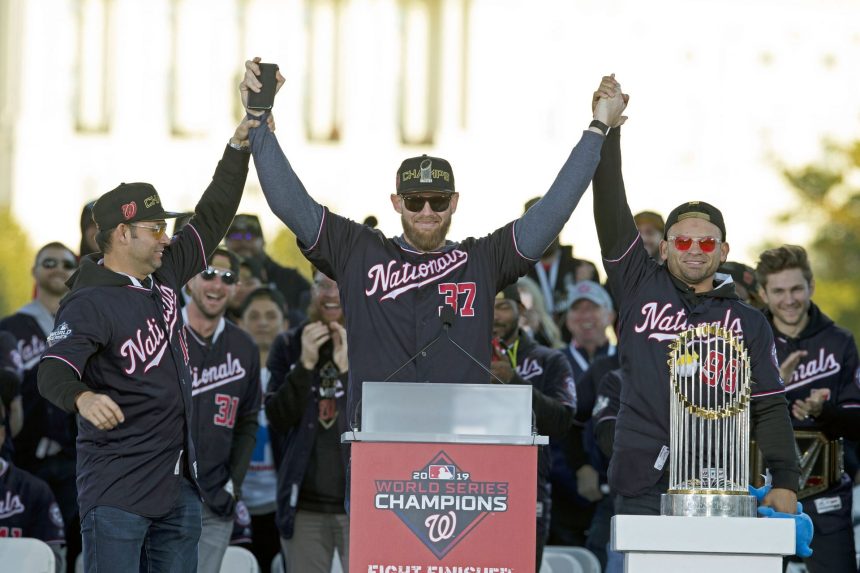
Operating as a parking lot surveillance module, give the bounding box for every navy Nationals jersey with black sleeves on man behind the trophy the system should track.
[594,129,797,496]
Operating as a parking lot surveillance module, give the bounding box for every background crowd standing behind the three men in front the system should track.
[5,200,860,571]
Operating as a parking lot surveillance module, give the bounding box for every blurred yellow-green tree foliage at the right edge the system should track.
[780,140,860,337]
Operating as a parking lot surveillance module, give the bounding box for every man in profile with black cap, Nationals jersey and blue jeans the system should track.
[38,113,273,573]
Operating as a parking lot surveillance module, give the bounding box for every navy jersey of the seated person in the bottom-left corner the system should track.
[0,459,66,543]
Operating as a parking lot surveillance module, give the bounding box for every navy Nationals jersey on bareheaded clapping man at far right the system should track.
[773,303,860,432]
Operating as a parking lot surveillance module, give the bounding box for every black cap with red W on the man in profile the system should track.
[93,183,185,231]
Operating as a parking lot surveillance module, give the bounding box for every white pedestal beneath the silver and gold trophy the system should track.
[612,515,794,573]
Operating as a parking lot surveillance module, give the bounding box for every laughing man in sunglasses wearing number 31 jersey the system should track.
[182,247,262,572]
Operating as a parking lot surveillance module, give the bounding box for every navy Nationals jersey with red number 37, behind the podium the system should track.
[305,209,534,420]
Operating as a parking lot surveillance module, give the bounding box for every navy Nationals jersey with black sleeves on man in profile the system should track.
[42,146,249,518]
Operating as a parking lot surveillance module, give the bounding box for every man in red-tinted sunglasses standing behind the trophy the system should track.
[594,77,800,515]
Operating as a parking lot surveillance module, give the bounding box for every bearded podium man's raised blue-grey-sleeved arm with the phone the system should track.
[239,58,323,246]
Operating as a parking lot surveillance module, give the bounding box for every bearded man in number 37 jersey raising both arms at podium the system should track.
[242,60,623,426]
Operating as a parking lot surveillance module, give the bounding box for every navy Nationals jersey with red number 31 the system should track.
[185,318,262,517]
